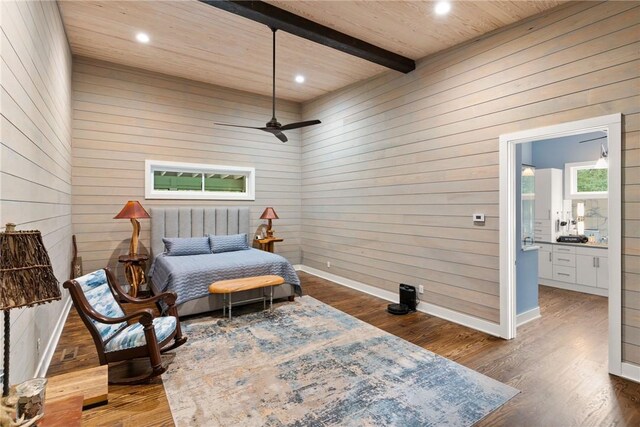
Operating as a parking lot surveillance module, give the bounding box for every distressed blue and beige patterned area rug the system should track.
[162,296,518,426]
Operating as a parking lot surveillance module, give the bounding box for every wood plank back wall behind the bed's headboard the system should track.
[72,57,301,275]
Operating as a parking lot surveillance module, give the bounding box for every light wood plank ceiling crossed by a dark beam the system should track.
[58,0,564,102]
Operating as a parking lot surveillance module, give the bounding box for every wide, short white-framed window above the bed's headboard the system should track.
[145,160,255,200]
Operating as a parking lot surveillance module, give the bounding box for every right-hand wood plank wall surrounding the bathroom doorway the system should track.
[302,2,640,363]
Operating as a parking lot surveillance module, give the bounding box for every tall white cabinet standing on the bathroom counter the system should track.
[533,169,564,242]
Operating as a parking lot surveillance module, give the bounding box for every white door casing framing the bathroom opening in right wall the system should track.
[500,114,640,381]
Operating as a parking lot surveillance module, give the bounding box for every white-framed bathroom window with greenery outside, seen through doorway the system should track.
[565,162,609,199]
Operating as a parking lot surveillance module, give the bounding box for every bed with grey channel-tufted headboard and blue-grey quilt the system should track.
[149,207,302,316]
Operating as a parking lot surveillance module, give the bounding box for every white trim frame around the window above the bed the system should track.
[144,160,256,200]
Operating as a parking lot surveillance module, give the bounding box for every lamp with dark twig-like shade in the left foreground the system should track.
[0,224,61,396]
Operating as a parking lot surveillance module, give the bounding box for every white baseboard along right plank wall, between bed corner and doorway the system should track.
[294,264,501,337]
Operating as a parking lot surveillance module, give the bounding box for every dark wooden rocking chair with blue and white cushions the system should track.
[64,268,187,384]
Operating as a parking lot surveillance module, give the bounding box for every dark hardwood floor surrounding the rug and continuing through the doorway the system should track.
[48,273,640,427]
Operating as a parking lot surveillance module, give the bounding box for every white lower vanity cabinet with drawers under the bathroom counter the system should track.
[536,243,609,296]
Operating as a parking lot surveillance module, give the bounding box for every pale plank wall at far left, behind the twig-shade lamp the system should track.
[0,1,71,383]
